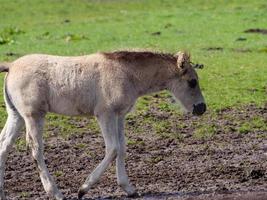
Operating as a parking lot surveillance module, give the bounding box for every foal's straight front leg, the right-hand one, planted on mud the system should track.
[116,116,136,196]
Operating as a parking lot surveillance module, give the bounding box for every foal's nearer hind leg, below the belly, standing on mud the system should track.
[24,116,64,200]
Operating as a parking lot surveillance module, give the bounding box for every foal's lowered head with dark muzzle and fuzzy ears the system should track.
[169,52,206,115]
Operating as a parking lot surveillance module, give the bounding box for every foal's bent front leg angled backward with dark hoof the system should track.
[78,111,119,199]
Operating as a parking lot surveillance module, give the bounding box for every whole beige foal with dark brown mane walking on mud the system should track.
[0,51,206,200]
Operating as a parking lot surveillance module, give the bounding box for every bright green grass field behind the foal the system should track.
[0,0,267,134]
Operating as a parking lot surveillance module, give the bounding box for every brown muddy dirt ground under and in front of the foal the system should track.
[2,105,267,200]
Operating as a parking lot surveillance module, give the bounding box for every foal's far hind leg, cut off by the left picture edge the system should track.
[0,109,23,200]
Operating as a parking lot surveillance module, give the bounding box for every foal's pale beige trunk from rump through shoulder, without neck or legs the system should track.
[4,53,134,115]
